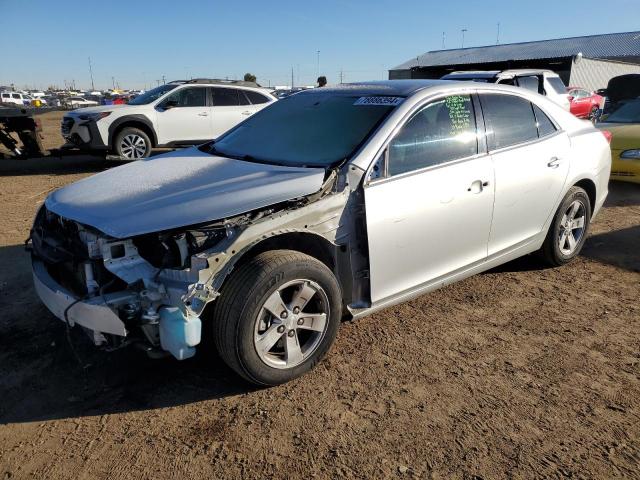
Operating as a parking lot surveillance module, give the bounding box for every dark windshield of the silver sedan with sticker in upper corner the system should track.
[211,92,403,167]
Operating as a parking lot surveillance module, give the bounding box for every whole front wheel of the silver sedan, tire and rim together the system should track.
[212,250,342,385]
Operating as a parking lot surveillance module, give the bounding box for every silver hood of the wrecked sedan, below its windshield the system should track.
[45,148,325,238]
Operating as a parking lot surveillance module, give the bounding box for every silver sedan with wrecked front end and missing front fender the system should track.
[31,81,611,385]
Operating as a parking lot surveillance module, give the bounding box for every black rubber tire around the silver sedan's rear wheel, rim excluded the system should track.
[540,186,591,267]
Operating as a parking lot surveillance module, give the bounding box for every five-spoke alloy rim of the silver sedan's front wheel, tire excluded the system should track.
[254,279,330,369]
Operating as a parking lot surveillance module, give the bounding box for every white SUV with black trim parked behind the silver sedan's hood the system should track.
[62,79,276,160]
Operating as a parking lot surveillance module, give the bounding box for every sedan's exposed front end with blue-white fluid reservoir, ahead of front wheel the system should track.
[30,207,227,360]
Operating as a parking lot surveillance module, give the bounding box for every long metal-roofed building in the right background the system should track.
[389,31,640,90]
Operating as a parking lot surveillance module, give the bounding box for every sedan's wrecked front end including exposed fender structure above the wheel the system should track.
[30,167,360,360]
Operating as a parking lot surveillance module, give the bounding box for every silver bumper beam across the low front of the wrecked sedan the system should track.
[32,258,127,338]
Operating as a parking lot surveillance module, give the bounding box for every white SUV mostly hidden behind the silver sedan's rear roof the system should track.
[442,69,569,111]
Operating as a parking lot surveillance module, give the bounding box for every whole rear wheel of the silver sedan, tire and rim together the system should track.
[541,187,591,266]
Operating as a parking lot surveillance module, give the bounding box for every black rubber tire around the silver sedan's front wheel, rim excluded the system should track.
[212,250,342,386]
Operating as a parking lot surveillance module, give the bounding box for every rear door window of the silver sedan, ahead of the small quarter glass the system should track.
[480,94,538,150]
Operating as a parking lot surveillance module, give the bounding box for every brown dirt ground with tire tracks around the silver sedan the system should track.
[0,110,640,480]
